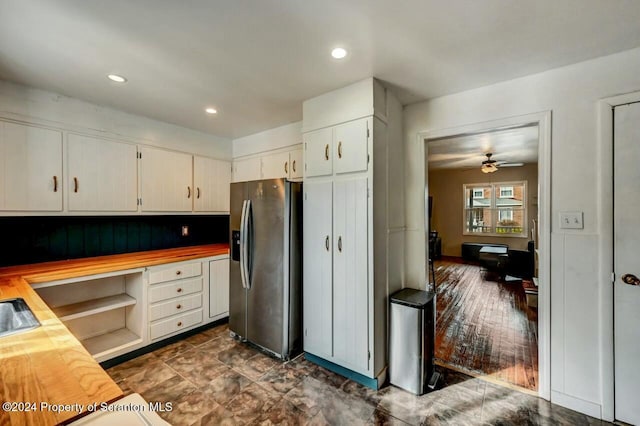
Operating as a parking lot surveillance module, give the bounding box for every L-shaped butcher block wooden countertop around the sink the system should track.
[0,244,229,425]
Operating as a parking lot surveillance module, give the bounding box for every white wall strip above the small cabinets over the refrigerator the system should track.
[233,121,302,158]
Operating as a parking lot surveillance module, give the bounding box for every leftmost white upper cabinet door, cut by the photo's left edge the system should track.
[0,122,62,211]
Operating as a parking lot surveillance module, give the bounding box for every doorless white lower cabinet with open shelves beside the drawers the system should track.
[32,270,146,362]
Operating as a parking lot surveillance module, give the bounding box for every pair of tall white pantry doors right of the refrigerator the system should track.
[303,177,371,374]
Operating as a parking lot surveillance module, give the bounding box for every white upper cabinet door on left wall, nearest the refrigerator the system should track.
[193,156,231,213]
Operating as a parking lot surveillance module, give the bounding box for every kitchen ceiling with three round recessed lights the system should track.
[0,0,640,138]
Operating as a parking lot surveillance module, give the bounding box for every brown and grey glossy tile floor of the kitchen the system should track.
[107,325,604,425]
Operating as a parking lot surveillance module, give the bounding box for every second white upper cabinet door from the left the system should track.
[67,134,138,211]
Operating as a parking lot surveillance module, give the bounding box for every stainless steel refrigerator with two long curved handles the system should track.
[229,179,302,359]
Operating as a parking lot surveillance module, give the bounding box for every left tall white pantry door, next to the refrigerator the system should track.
[302,182,333,358]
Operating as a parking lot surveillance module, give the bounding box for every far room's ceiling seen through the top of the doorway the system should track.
[427,125,538,170]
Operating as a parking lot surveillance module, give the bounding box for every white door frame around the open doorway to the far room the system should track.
[418,111,551,400]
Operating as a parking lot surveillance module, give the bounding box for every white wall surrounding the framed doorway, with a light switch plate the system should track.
[404,45,640,416]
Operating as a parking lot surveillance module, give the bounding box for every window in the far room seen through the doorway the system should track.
[463,181,527,237]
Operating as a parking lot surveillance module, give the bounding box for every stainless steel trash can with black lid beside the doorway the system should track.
[389,288,438,395]
